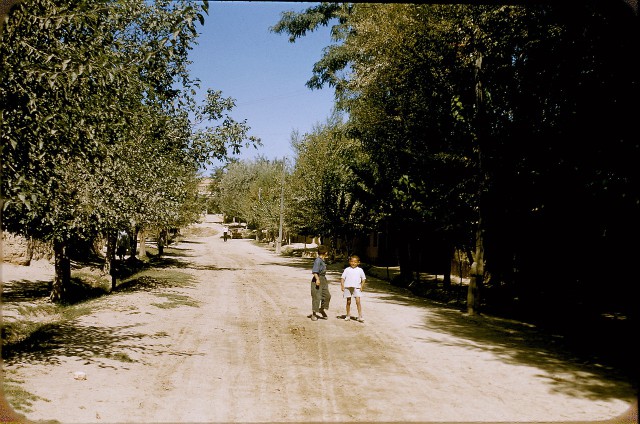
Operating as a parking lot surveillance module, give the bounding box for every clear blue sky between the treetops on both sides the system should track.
[189,1,334,171]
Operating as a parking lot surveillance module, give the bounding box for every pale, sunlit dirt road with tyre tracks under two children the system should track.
[4,216,635,423]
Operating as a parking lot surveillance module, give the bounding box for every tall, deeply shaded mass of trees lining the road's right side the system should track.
[272,1,640,320]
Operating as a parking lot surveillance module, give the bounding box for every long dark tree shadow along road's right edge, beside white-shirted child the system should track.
[366,277,638,399]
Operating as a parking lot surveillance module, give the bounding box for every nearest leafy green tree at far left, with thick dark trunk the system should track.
[2,1,156,300]
